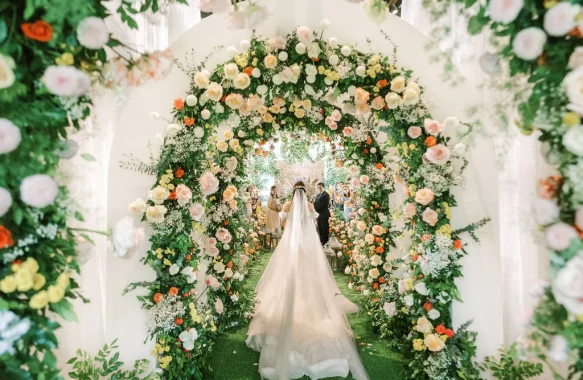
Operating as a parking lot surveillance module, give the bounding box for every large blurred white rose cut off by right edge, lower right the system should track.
[552,252,583,315]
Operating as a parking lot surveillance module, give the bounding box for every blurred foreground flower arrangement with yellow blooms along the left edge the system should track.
[0,0,172,378]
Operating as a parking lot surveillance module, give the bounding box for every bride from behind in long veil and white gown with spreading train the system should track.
[246,182,369,380]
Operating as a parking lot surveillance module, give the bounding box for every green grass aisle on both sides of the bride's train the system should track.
[207,253,403,380]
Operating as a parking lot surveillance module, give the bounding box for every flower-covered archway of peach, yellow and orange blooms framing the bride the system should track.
[131,27,488,378]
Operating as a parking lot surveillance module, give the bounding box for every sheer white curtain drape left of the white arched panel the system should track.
[56,0,200,376]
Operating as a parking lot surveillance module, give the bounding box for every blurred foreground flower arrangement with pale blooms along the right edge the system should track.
[425,0,583,377]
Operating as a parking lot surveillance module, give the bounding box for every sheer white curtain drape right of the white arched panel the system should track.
[402,0,552,343]
